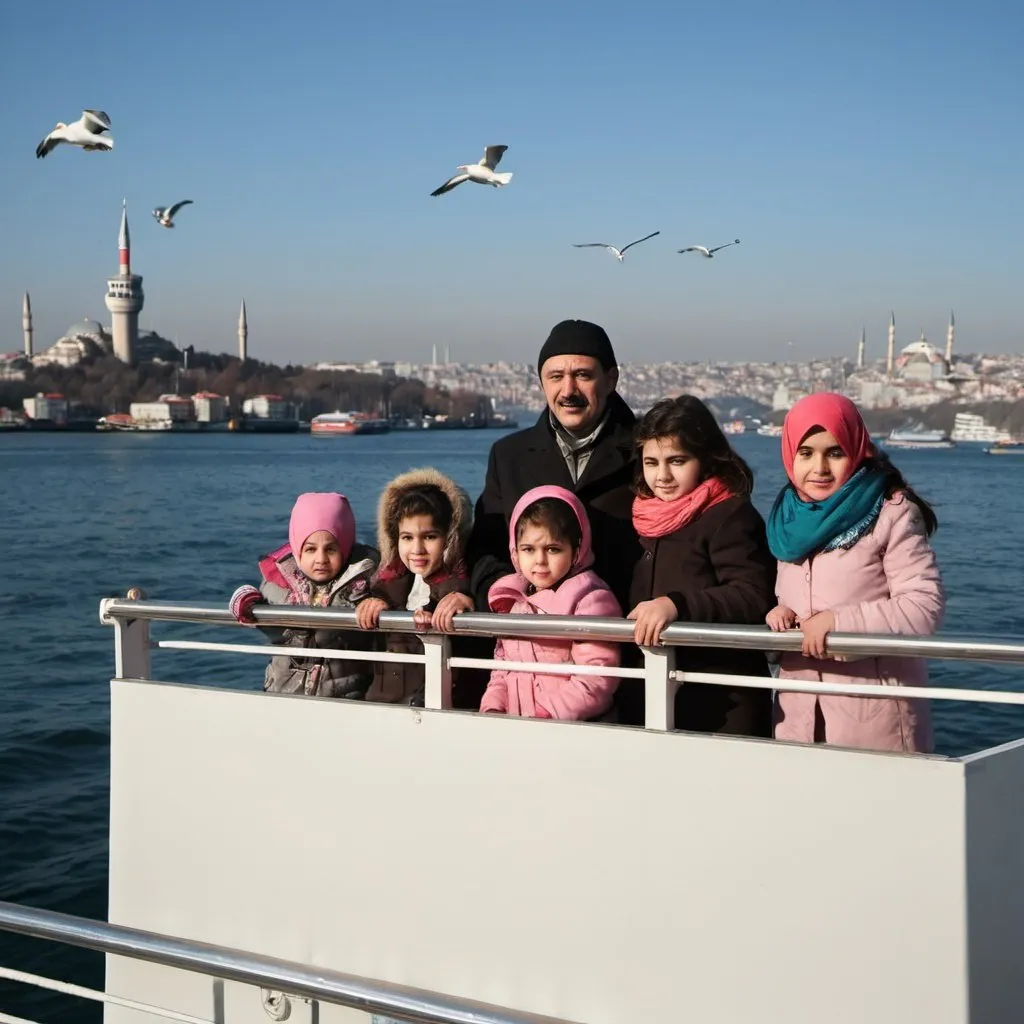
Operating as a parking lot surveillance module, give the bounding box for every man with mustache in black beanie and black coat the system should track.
[467,319,642,611]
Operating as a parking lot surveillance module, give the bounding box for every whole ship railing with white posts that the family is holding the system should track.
[99,591,1024,730]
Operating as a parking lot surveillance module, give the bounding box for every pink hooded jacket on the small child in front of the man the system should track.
[480,486,623,720]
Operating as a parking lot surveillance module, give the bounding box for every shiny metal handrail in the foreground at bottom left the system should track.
[0,901,577,1024]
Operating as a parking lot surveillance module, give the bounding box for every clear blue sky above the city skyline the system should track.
[0,0,1024,361]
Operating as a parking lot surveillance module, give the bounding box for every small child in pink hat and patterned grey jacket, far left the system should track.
[228,493,379,698]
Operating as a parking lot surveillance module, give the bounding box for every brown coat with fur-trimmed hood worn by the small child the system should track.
[366,469,473,708]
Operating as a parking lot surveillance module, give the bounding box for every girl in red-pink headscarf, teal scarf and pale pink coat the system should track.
[767,393,944,753]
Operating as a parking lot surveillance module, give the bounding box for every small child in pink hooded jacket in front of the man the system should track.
[480,486,623,719]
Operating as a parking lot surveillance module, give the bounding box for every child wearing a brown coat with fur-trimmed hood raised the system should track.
[355,469,473,708]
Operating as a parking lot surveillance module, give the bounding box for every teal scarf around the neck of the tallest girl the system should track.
[768,466,886,562]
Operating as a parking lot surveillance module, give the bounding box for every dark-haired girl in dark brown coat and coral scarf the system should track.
[627,394,775,736]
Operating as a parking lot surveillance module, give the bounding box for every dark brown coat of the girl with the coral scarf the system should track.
[630,498,776,736]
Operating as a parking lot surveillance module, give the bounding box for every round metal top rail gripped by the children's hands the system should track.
[100,598,1024,665]
